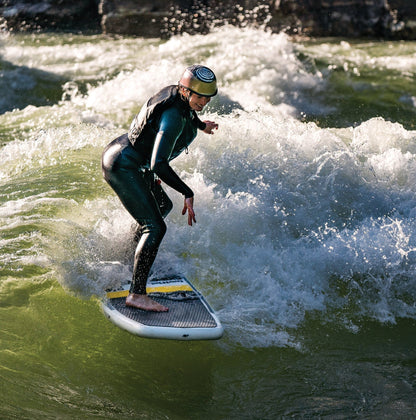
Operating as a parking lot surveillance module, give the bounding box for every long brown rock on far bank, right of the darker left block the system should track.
[96,0,416,39]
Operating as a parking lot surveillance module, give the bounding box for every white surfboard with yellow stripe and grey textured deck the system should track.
[102,276,224,340]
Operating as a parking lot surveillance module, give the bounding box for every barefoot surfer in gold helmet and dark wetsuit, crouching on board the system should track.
[102,65,218,312]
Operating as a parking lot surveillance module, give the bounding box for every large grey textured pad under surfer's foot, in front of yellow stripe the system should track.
[109,296,217,328]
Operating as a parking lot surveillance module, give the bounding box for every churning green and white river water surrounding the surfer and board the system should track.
[0,27,416,419]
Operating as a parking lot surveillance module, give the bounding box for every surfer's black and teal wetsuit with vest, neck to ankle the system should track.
[102,86,205,294]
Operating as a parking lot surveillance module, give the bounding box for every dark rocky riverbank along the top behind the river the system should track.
[0,0,416,39]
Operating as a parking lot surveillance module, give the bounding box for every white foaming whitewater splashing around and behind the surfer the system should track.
[0,27,416,348]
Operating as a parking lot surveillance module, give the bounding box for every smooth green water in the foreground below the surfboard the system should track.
[1,288,416,419]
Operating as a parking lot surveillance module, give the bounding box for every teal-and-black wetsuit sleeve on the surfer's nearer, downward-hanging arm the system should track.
[150,108,194,198]
